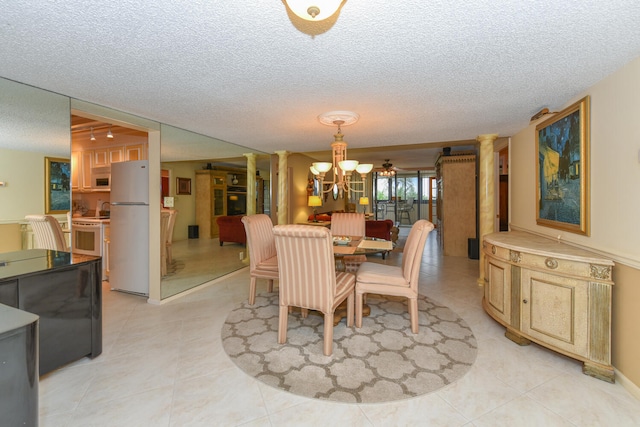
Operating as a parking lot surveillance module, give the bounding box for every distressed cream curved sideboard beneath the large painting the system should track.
[482,231,614,382]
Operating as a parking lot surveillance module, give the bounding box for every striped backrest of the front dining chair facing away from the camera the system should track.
[273,225,336,312]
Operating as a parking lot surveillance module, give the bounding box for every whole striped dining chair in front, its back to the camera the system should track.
[273,225,355,356]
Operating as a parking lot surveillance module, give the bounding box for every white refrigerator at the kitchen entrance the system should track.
[109,160,149,295]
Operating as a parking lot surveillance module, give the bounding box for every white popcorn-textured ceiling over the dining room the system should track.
[0,0,640,167]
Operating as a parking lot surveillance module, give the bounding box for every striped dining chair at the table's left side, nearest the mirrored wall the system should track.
[242,214,278,305]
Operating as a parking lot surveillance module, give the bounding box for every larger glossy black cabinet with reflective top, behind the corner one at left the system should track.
[0,249,102,375]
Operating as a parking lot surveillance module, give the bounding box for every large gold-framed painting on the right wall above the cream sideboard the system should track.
[536,96,590,236]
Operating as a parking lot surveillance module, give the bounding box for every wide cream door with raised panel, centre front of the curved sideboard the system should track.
[522,269,589,357]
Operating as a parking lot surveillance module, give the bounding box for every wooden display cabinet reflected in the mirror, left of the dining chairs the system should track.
[196,169,227,238]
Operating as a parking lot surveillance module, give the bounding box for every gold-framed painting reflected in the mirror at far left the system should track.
[44,157,71,215]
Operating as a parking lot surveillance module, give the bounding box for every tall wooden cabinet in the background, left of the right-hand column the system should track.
[436,151,476,256]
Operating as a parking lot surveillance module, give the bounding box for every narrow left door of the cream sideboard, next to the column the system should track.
[484,256,512,324]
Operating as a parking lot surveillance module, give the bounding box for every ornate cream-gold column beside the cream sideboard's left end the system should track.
[476,133,498,286]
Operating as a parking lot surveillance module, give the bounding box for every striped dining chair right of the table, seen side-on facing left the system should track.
[356,219,433,334]
